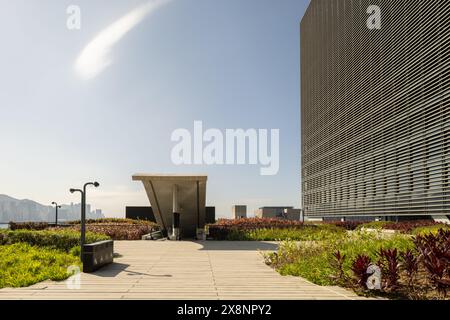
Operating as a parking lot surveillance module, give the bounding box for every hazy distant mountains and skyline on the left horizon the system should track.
[0,194,104,223]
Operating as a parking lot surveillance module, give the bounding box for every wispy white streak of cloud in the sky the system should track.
[75,0,171,79]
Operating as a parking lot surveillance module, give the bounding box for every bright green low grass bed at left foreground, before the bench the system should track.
[0,243,81,288]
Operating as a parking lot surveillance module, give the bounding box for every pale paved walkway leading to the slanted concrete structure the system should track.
[0,241,364,300]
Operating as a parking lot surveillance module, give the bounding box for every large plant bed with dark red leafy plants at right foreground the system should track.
[264,229,450,299]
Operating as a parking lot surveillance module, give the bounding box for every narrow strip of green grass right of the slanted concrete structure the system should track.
[227,224,346,241]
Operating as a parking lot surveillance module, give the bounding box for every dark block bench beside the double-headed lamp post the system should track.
[83,240,114,273]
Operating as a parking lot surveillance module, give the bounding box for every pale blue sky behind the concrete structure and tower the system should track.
[0,0,309,217]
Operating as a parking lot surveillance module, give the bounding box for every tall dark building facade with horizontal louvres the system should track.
[301,0,450,219]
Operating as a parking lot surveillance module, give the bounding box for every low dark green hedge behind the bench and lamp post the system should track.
[0,230,110,252]
